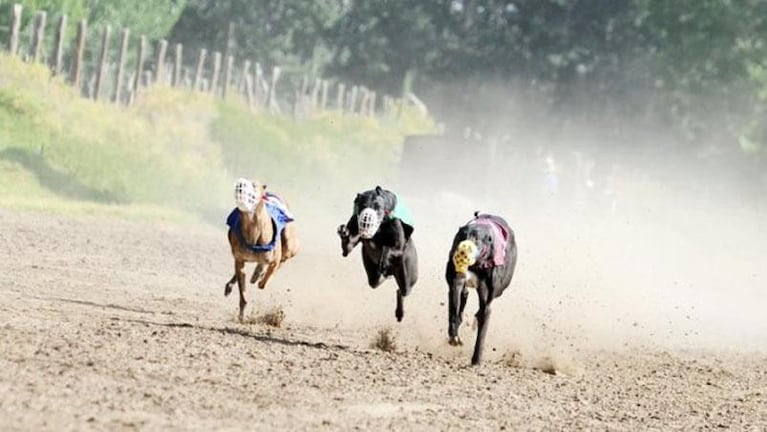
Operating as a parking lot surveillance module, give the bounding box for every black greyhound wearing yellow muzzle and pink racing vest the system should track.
[445,213,517,365]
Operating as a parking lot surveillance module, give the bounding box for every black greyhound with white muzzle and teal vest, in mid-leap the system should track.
[338,186,418,321]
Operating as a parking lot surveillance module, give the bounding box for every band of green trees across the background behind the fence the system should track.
[0,0,767,155]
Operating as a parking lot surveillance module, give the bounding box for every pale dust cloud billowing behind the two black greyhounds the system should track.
[252,82,767,362]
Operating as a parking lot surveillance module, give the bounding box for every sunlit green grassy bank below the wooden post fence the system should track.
[0,53,432,223]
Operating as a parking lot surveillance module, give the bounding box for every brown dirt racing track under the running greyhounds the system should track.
[0,210,767,431]
